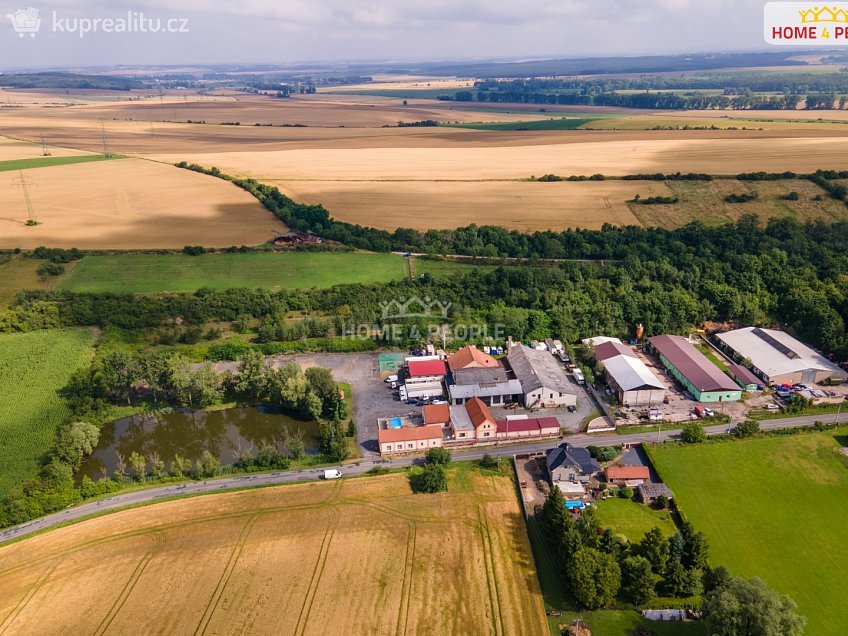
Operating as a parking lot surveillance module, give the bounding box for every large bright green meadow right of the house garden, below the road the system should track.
[651,429,848,636]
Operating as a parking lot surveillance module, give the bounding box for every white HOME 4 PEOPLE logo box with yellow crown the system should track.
[763,2,848,47]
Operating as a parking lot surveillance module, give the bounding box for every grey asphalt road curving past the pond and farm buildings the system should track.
[0,414,845,544]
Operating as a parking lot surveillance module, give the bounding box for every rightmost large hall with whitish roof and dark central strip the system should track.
[716,327,848,385]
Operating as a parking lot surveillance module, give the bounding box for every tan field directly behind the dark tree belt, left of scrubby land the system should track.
[273,181,656,231]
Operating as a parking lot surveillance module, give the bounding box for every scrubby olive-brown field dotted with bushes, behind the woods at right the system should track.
[630,179,848,228]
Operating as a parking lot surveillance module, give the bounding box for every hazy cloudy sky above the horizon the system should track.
[0,0,780,69]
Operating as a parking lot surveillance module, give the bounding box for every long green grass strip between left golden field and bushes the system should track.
[59,252,407,294]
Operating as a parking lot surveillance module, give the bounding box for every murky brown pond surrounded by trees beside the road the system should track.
[79,407,321,480]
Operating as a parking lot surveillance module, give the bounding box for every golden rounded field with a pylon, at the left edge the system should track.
[0,159,283,249]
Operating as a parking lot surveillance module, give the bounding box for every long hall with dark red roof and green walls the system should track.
[648,336,742,402]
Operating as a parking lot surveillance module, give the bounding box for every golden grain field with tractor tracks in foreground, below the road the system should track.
[0,467,546,634]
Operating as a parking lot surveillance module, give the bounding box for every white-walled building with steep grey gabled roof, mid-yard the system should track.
[507,345,577,408]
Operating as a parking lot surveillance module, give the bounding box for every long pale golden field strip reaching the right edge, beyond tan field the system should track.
[159,135,845,181]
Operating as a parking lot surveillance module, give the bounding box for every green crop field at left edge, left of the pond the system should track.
[0,329,94,497]
